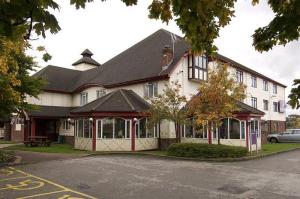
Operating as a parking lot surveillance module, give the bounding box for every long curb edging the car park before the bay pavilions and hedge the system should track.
[83,148,300,162]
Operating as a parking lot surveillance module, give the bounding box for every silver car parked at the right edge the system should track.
[267,129,300,143]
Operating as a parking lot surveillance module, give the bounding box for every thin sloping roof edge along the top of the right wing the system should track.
[216,54,286,88]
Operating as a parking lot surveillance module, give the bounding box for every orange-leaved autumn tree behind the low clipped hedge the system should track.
[187,63,246,144]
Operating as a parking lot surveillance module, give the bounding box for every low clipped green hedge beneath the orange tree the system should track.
[167,143,248,158]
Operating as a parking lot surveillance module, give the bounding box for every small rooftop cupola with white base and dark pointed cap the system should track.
[72,49,101,71]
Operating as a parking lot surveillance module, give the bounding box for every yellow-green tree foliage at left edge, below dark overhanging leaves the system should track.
[0,37,44,118]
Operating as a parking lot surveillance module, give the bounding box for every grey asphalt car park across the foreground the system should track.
[0,150,300,199]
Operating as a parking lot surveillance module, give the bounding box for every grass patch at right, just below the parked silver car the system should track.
[260,143,300,155]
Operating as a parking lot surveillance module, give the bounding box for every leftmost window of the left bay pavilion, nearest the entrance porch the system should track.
[75,119,93,138]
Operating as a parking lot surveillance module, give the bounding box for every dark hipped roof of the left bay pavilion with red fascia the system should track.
[71,89,150,113]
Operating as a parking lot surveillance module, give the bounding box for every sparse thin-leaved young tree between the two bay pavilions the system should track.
[148,82,186,142]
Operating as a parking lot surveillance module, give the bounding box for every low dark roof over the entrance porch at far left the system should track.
[28,106,74,117]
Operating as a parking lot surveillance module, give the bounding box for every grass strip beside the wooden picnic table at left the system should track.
[4,144,89,154]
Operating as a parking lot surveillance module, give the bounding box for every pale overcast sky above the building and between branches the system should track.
[28,0,300,114]
